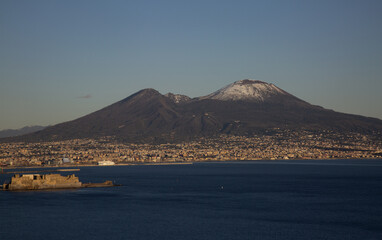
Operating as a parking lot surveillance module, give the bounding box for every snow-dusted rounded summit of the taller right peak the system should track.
[199,79,288,102]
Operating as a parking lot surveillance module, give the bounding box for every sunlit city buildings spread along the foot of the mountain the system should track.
[0,129,382,167]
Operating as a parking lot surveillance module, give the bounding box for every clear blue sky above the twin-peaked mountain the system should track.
[0,0,382,129]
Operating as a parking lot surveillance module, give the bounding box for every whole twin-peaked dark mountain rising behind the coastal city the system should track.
[7,79,382,142]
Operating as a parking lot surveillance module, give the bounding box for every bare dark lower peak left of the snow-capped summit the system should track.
[28,89,179,140]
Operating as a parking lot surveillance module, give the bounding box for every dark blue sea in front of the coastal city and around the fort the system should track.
[0,160,382,240]
